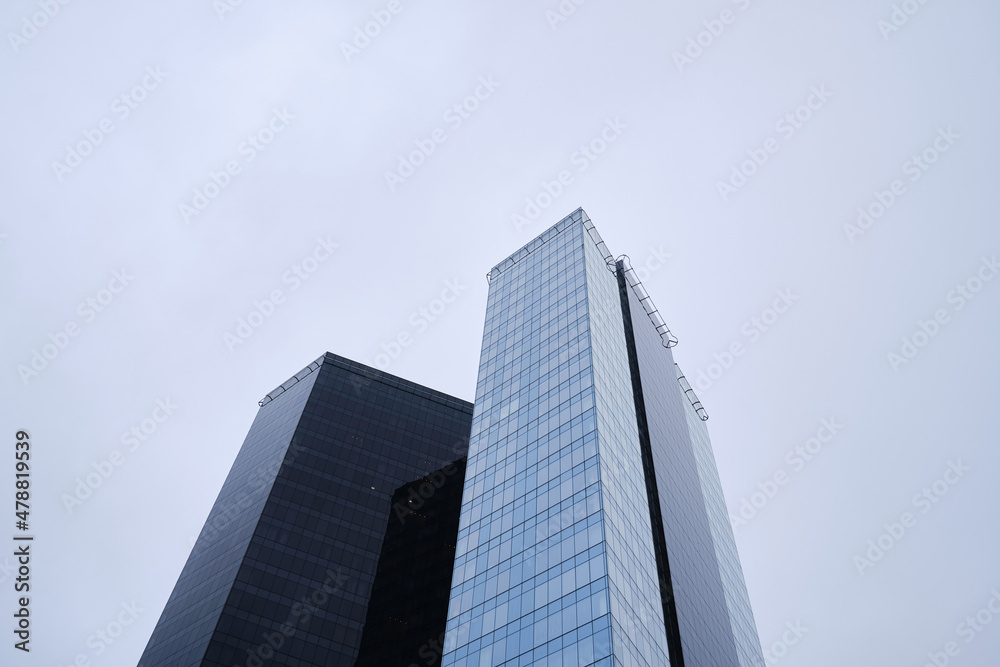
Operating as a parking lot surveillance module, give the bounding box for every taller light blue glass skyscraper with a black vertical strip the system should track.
[442,209,764,667]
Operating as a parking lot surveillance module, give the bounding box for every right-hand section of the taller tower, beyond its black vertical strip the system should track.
[625,239,764,667]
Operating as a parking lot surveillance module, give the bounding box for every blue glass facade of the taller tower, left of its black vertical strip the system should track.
[442,211,666,667]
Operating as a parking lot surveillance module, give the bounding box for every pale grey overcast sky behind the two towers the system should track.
[0,0,1000,667]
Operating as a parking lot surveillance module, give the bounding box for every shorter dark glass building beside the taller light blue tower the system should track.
[139,353,472,667]
